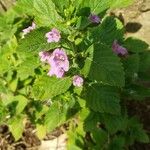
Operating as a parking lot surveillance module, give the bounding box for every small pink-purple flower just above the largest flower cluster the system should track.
[45,28,61,43]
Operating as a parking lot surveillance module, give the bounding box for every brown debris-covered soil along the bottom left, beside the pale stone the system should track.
[0,123,67,150]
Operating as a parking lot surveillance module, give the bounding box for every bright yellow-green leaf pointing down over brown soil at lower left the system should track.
[9,117,24,141]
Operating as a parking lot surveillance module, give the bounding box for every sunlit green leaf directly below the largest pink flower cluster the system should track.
[33,76,72,100]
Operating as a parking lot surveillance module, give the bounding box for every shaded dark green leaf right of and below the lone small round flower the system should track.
[84,84,120,115]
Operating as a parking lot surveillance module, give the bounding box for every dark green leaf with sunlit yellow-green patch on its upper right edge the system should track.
[91,16,124,46]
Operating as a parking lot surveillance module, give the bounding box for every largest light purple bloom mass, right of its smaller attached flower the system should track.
[48,48,69,78]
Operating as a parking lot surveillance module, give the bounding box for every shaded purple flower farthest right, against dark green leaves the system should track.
[112,40,128,56]
